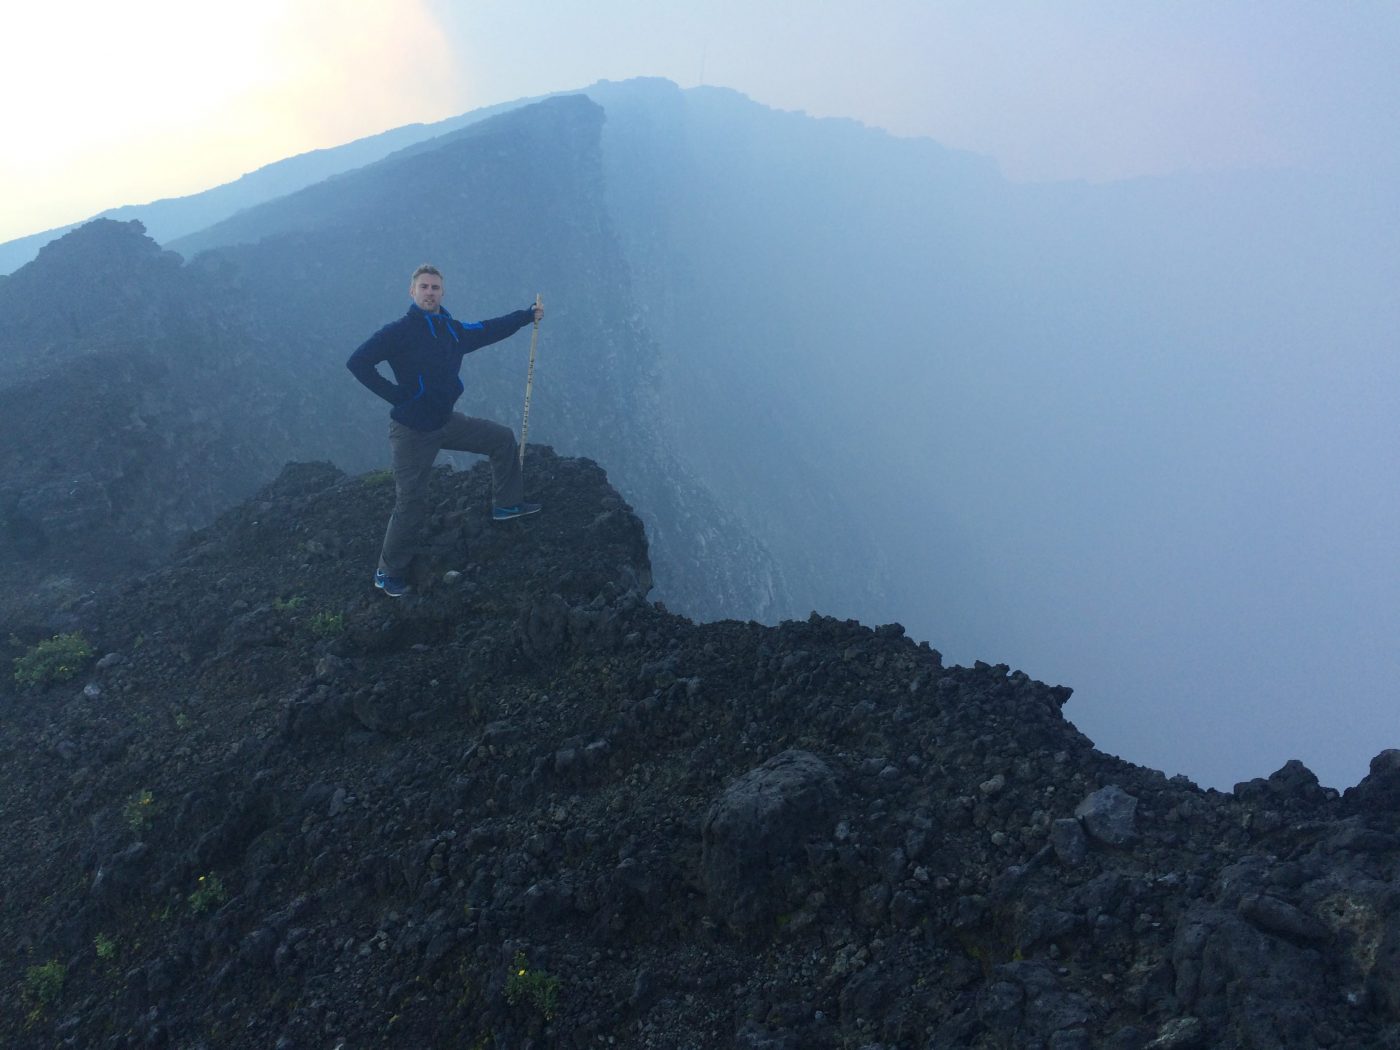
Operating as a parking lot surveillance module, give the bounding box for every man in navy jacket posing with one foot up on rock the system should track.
[346,265,545,598]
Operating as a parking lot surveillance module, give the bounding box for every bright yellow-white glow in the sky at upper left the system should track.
[0,0,465,241]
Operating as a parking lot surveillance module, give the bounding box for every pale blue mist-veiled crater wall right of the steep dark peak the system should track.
[576,81,1400,787]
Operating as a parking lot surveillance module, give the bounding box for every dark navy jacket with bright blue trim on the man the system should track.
[346,302,535,430]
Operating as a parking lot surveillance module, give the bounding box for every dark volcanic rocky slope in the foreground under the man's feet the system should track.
[0,449,1400,1050]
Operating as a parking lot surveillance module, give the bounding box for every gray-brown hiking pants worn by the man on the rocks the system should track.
[379,412,524,578]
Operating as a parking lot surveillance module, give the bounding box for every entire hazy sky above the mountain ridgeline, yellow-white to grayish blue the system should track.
[0,0,1400,239]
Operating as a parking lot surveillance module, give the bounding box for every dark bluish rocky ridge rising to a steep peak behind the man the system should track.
[0,97,787,632]
